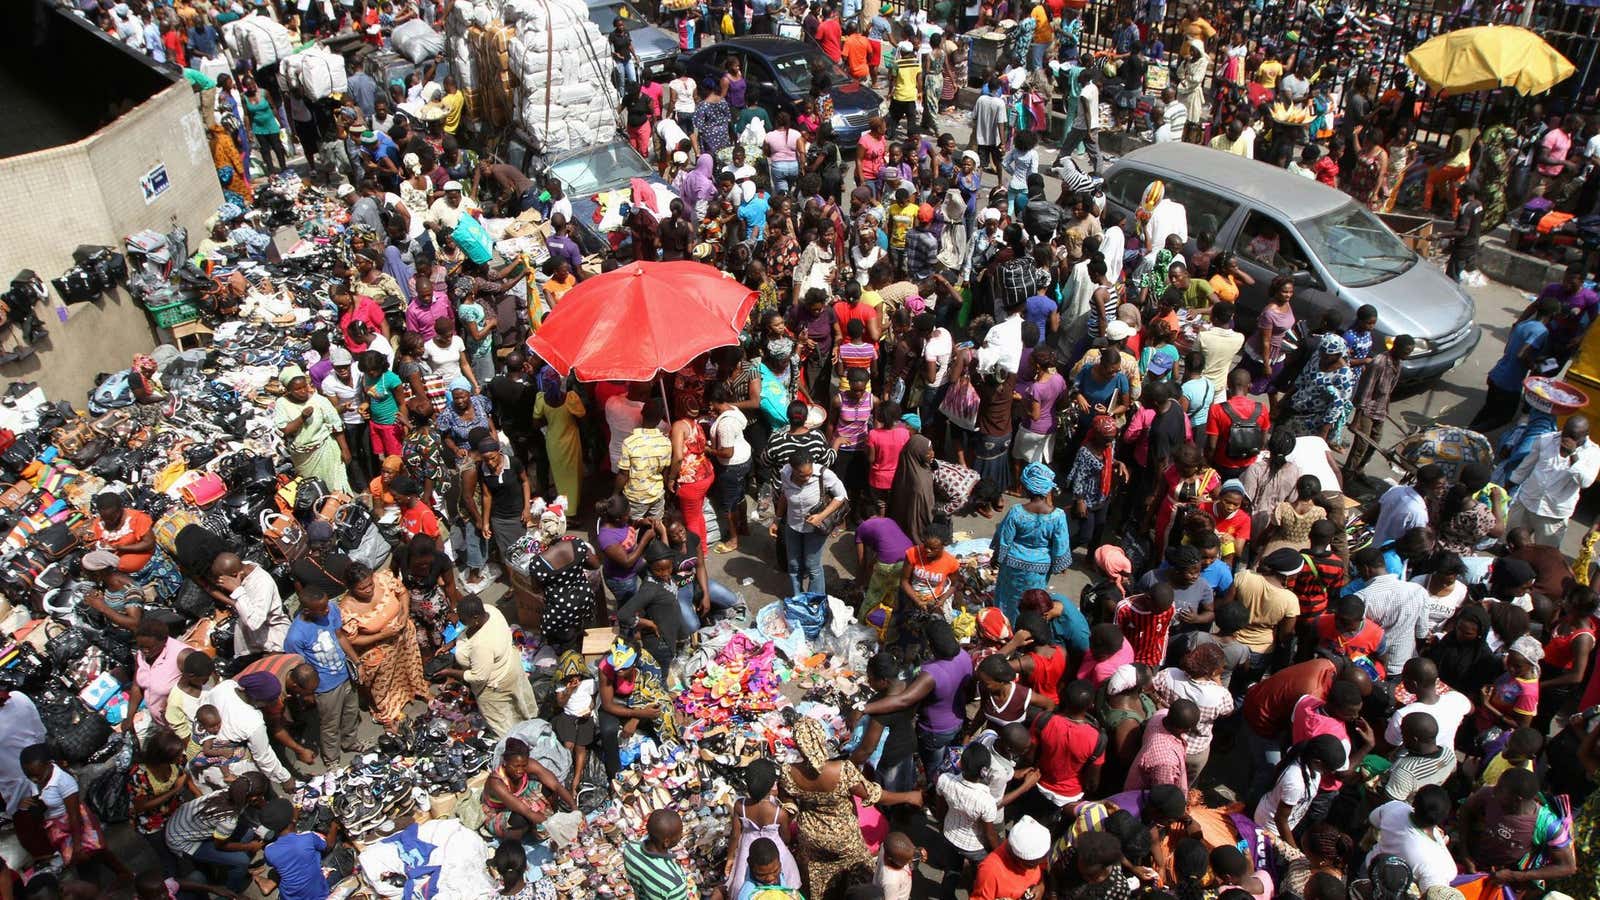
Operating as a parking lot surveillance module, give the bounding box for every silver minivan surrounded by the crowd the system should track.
[1106,143,1483,383]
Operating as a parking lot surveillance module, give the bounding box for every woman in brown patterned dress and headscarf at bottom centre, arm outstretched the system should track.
[778,719,922,900]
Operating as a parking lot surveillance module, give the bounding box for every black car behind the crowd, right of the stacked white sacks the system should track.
[685,35,883,147]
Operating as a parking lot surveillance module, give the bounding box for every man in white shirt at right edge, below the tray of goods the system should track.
[1506,415,1600,544]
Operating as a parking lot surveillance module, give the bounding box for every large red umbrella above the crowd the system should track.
[528,261,755,381]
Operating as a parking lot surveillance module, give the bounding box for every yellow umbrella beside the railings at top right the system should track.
[1405,26,1578,96]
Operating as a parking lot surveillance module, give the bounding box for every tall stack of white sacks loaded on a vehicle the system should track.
[450,0,619,154]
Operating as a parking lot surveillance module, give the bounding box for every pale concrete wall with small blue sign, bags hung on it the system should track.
[0,82,222,408]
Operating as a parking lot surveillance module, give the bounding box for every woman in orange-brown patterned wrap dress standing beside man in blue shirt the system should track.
[339,564,427,732]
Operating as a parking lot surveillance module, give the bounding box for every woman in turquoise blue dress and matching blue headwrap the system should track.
[990,463,1072,621]
